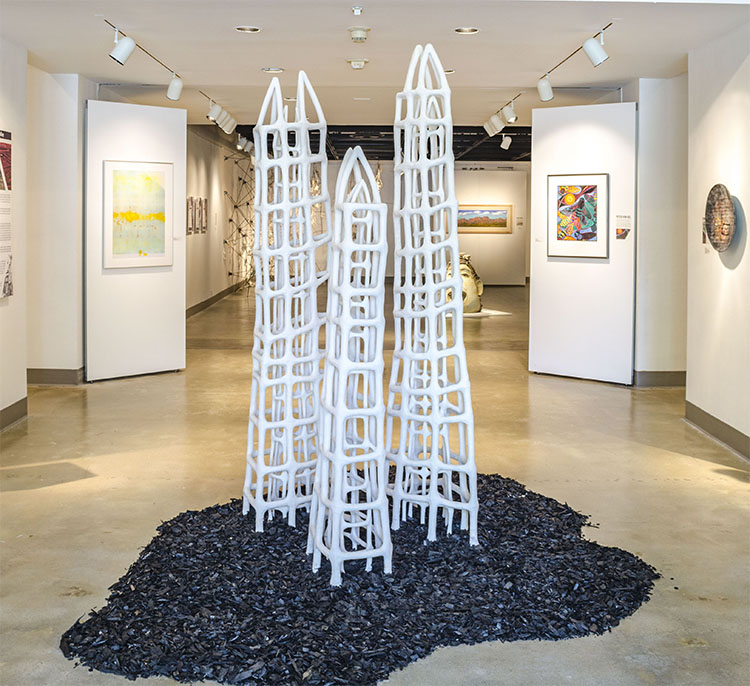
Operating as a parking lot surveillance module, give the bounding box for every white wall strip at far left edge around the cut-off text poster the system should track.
[0,38,27,428]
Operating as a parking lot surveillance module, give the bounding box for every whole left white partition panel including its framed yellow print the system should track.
[84,100,187,381]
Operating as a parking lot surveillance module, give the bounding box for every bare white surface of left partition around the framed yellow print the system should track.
[85,100,187,381]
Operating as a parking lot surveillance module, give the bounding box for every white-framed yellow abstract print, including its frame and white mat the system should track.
[102,160,174,269]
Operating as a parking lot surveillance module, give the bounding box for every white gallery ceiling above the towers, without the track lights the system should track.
[0,0,750,125]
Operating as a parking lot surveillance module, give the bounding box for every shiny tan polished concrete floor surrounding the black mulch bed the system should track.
[0,288,750,686]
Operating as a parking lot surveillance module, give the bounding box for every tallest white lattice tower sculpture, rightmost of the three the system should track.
[386,44,478,545]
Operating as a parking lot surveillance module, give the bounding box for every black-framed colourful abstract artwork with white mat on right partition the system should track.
[547,174,609,258]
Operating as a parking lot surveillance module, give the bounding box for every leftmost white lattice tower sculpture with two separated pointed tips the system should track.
[243,72,330,531]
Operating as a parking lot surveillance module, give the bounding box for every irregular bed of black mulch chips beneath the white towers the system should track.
[60,475,659,686]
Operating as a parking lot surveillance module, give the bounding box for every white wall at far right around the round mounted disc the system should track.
[686,24,750,454]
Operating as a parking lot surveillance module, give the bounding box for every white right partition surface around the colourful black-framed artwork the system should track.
[529,103,637,384]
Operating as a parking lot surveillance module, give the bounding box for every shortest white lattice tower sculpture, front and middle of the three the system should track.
[308,147,392,586]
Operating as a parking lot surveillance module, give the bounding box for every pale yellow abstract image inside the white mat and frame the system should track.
[112,169,166,257]
